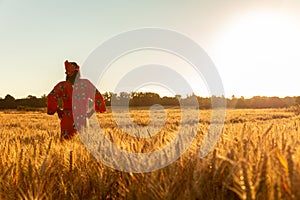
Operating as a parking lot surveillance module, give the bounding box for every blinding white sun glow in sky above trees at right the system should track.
[214,13,300,96]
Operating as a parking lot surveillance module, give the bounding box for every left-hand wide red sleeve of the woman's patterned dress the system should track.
[47,82,63,115]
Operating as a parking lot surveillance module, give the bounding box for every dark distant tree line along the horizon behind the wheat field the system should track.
[0,92,300,110]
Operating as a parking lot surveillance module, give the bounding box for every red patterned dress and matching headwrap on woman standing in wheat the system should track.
[47,61,106,139]
